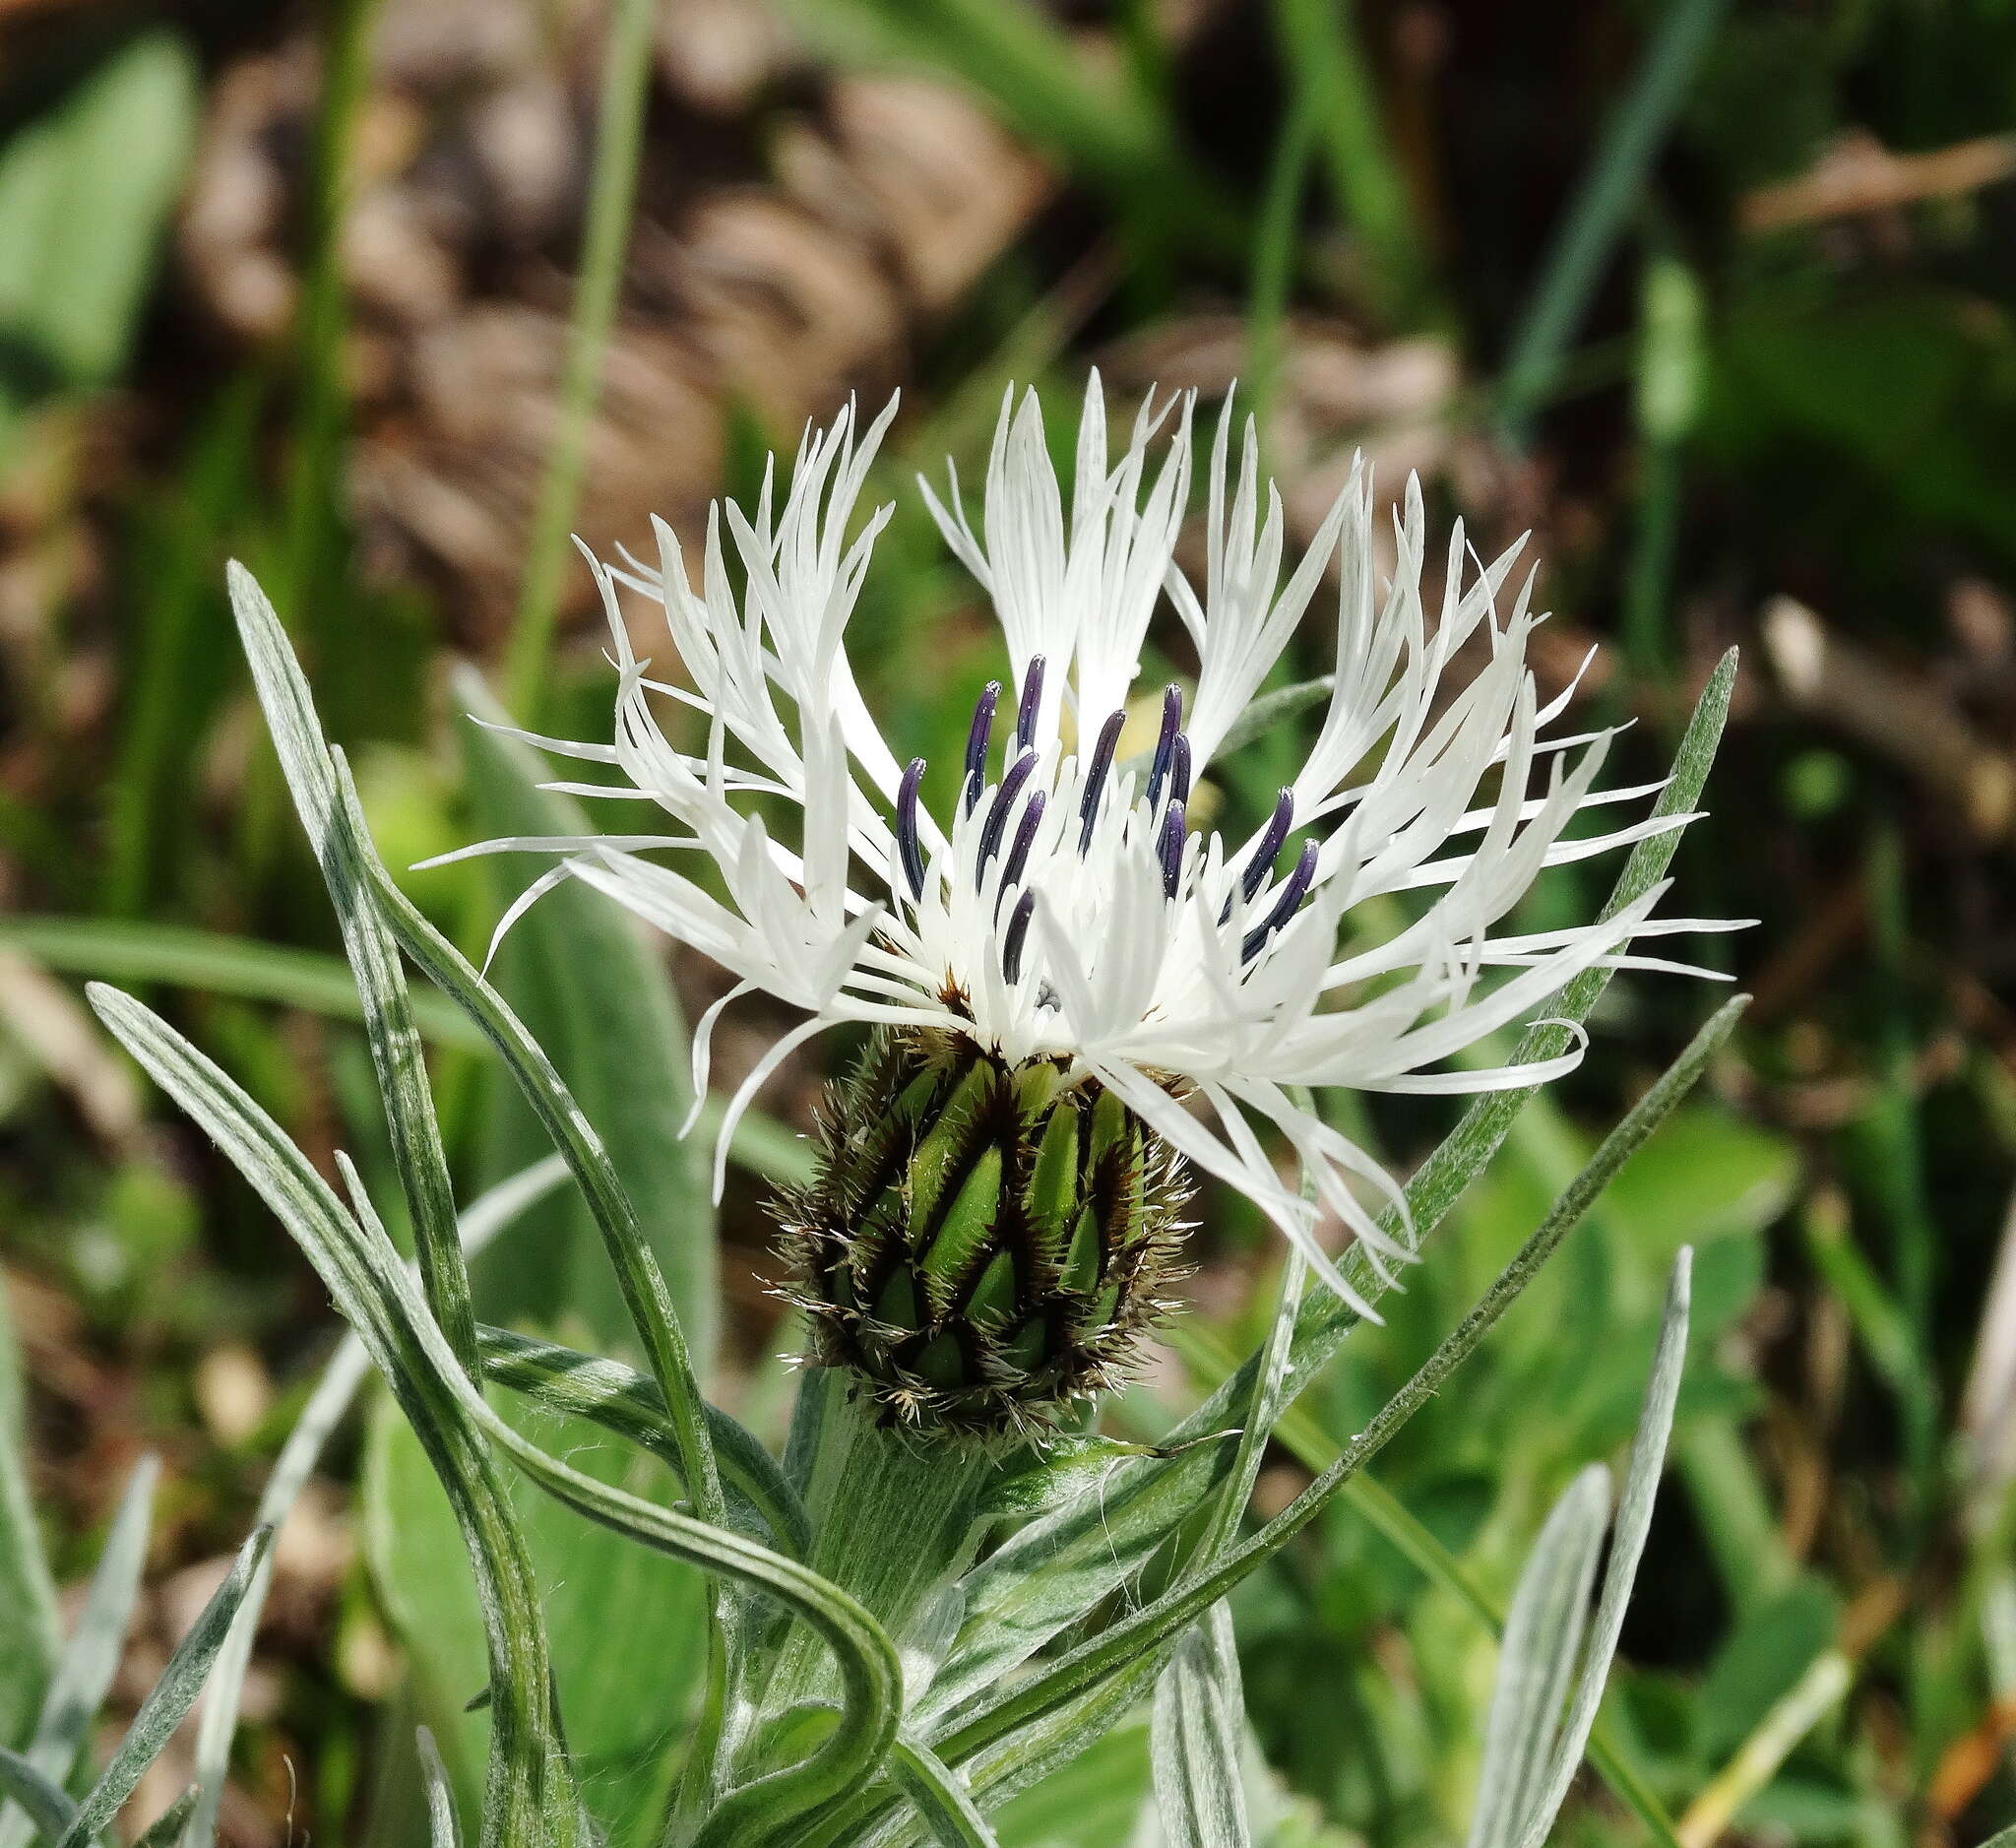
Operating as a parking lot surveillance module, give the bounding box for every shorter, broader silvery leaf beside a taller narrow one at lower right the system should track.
[1470,1463,1610,1848]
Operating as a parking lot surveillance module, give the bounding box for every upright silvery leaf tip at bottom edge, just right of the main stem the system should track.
[1149,1604,1252,1848]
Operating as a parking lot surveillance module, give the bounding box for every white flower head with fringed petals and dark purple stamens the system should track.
[445,377,1716,1296]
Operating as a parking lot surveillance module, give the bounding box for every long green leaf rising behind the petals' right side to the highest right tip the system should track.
[931,649,1735,1709]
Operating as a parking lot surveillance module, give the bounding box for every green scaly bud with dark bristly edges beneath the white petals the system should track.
[785,1030,1187,1433]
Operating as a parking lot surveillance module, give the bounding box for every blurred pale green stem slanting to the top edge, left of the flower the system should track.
[504,0,658,716]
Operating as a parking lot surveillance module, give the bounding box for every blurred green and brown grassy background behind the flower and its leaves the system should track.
[0,0,2016,1848]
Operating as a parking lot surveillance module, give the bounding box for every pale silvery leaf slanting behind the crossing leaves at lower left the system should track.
[181,1155,566,1848]
